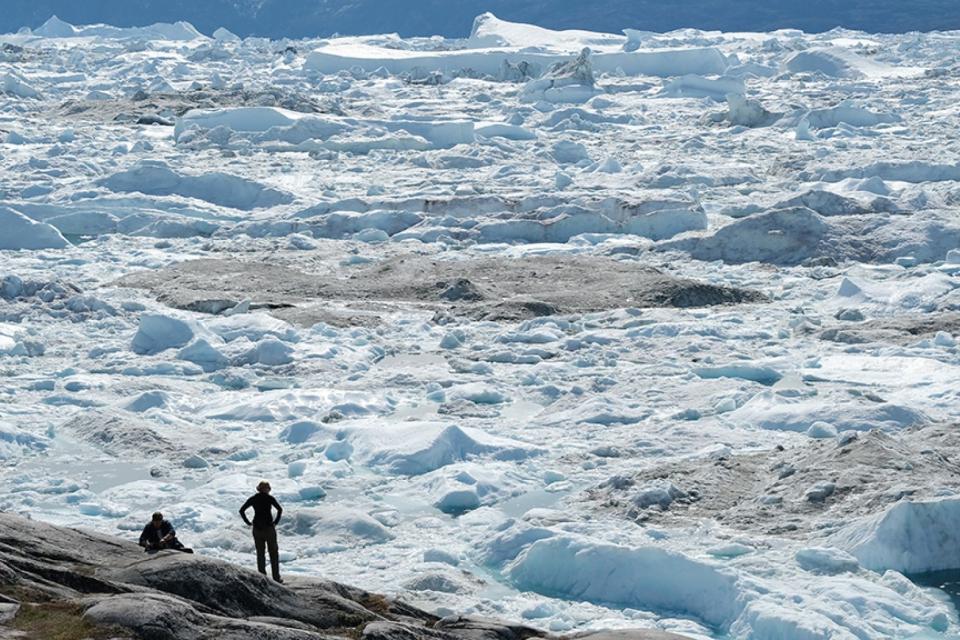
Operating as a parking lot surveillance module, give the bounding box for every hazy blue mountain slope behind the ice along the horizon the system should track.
[0,0,960,38]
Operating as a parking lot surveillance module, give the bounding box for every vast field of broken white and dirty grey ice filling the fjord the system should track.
[0,14,960,640]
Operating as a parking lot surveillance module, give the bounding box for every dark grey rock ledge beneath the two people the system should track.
[0,513,683,640]
